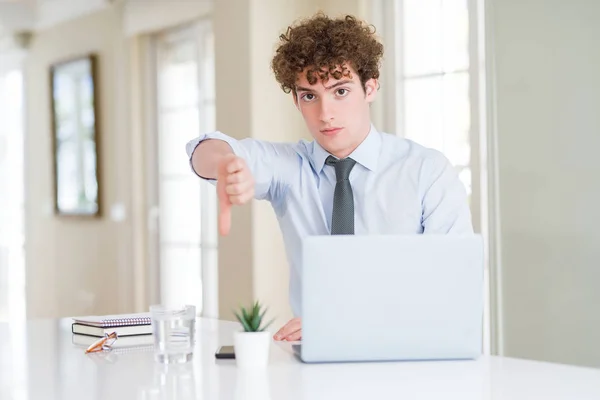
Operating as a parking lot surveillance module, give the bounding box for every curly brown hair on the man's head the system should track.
[271,13,383,93]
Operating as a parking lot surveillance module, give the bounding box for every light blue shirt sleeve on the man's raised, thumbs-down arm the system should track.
[186,131,295,201]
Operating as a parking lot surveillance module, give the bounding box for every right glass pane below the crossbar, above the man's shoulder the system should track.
[442,73,471,165]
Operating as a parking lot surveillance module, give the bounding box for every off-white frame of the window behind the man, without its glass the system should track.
[371,0,494,354]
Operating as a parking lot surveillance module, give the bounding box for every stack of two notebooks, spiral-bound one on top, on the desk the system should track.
[71,313,152,337]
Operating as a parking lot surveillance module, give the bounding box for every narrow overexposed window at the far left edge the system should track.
[0,64,27,398]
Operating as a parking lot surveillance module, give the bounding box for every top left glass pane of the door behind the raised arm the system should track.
[158,41,198,108]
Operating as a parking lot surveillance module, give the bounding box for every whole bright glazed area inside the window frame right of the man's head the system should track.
[396,0,472,195]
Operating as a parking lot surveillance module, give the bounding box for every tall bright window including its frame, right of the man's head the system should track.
[373,0,490,353]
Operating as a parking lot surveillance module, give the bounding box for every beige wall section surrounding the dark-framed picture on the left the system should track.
[24,7,133,318]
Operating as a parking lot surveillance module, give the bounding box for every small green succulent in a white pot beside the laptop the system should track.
[233,301,273,367]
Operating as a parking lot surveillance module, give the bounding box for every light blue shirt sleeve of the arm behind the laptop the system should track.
[421,151,473,234]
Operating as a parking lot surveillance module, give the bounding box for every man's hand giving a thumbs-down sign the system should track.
[217,154,254,235]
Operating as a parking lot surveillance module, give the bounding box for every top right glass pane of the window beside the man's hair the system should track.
[442,0,469,71]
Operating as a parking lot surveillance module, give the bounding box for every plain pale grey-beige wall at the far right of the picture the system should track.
[490,0,600,367]
